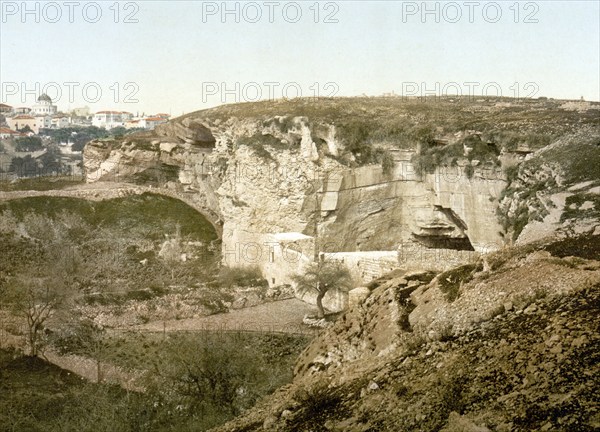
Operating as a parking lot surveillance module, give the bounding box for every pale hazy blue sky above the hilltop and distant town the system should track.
[0,0,600,115]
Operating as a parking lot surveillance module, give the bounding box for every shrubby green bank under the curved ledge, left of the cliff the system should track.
[0,194,216,310]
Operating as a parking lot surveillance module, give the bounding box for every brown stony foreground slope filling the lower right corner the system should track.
[211,236,600,432]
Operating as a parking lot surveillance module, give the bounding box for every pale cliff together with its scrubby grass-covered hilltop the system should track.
[84,99,595,284]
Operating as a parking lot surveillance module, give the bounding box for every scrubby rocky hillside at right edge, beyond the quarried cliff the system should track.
[498,129,600,243]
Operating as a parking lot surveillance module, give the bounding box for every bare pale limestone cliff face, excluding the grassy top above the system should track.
[84,113,505,284]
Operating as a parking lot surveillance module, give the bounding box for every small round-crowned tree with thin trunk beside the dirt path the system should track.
[292,260,352,318]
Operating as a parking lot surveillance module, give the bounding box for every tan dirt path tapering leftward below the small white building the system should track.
[133,299,315,334]
